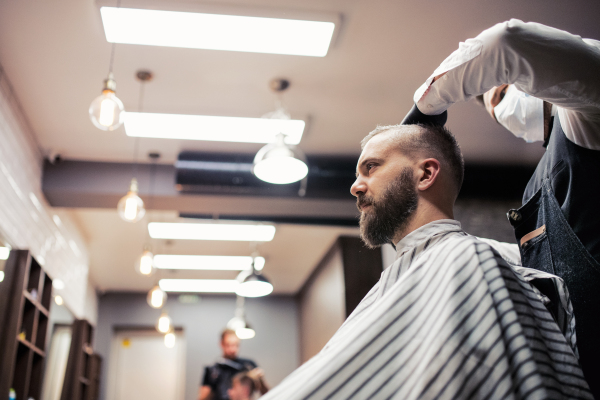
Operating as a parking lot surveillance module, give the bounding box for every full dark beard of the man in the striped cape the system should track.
[356,167,419,249]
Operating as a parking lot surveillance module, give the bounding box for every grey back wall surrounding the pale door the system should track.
[94,293,300,400]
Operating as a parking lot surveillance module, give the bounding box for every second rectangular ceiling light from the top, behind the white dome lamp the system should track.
[125,112,305,144]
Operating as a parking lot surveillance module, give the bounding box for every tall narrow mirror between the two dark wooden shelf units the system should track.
[41,296,74,400]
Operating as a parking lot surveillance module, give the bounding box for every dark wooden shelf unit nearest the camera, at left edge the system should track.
[0,250,52,400]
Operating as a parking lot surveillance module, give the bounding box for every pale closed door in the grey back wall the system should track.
[108,328,185,400]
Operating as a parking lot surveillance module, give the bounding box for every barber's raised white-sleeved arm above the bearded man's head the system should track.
[414,19,600,150]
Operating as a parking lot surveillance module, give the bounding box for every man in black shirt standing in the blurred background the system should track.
[198,329,269,400]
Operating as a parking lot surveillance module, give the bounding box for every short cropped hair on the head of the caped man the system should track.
[360,124,465,195]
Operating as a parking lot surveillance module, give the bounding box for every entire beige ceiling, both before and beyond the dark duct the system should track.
[0,0,600,293]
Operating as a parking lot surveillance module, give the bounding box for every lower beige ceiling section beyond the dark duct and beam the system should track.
[71,209,357,294]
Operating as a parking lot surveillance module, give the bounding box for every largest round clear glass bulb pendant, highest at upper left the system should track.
[88,72,125,131]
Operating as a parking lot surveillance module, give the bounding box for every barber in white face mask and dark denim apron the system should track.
[413,19,600,398]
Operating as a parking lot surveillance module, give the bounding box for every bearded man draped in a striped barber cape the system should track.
[262,125,592,400]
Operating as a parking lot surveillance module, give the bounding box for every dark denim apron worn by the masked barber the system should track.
[508,118,600,399]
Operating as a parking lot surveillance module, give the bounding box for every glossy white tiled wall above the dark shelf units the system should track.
[0,66,97,323]
